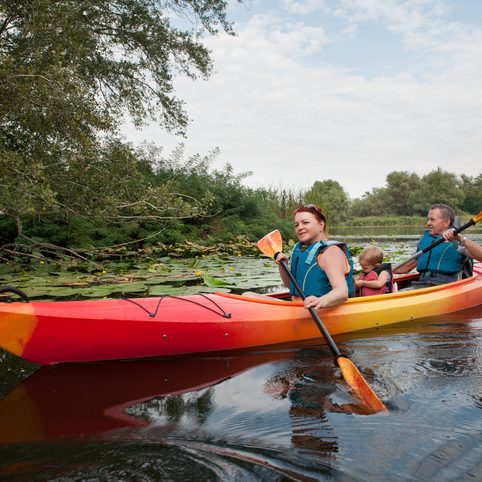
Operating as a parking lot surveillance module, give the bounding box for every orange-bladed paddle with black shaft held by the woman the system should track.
[257,229,387,413]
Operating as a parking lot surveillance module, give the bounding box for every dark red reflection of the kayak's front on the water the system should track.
[0,352,292,443]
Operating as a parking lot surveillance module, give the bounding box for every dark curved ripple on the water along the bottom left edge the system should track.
[2,433,356,482]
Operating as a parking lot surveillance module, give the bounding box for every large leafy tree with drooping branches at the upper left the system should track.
[0,0,238,241]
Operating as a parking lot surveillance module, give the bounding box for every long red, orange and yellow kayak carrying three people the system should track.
[0,264,482,365]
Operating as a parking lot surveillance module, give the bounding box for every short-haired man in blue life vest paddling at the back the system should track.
[394,204,482,289]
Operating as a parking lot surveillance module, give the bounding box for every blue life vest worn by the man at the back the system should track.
[417,231,462,275]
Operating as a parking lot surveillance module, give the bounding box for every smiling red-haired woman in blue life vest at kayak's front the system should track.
[275,204,353,309]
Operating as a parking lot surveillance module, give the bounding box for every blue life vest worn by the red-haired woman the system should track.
[290,241,353,297]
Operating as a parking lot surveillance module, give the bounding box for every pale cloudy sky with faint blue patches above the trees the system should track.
[120,0,482,198]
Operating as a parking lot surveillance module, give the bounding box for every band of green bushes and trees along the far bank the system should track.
[0,144,482,249]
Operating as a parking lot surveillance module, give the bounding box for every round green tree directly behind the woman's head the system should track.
[304,179,350,224]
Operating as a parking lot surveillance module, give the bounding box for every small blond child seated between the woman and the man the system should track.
[356,246,393,296]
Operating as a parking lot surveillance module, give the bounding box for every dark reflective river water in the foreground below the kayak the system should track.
[0,232,482,481]
